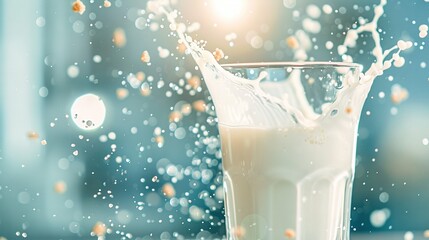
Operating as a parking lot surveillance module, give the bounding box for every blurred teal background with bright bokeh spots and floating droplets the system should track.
[0,0,429,240]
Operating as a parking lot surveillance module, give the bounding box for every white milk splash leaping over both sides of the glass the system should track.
[147,0,412,127]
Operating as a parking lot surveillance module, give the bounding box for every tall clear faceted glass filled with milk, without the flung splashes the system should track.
[199,62,364,240]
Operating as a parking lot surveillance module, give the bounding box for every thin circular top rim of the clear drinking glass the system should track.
[221,61,363,70]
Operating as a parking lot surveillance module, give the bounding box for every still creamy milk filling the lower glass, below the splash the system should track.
[219,125,356,240]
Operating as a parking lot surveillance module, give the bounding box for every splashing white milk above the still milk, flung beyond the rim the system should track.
[147,0,412,127]
